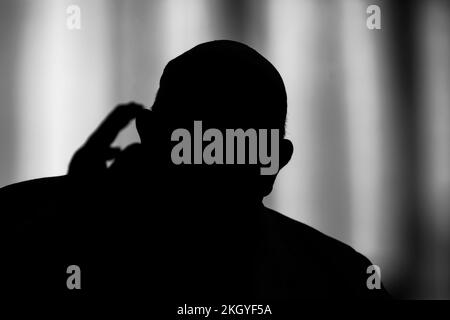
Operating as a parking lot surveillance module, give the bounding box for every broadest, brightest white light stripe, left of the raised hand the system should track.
[16,0,111,180]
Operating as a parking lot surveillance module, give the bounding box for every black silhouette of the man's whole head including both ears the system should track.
[137,40,292,202]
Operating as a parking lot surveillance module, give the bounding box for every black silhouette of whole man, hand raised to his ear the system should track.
[0,41,386,301]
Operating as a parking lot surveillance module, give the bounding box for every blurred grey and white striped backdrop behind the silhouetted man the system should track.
[0,0,450,299]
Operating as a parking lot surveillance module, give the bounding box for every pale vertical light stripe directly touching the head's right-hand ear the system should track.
[267,0,319,228]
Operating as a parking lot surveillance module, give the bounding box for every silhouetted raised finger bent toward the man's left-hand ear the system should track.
[85,102,144,150]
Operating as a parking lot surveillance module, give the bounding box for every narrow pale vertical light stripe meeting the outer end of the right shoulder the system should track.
[341,1,385,257]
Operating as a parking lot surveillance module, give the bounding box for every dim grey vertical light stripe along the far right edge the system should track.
[417,1,450,299]
